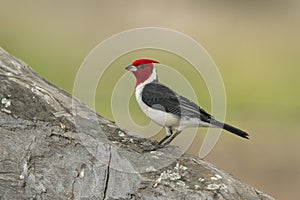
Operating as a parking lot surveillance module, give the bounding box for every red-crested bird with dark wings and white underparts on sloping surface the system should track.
[125,58,249,146]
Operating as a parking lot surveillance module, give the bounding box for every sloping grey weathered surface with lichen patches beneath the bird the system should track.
[0,48,273,200]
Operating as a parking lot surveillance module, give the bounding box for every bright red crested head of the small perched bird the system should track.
[125,59,159,86]
